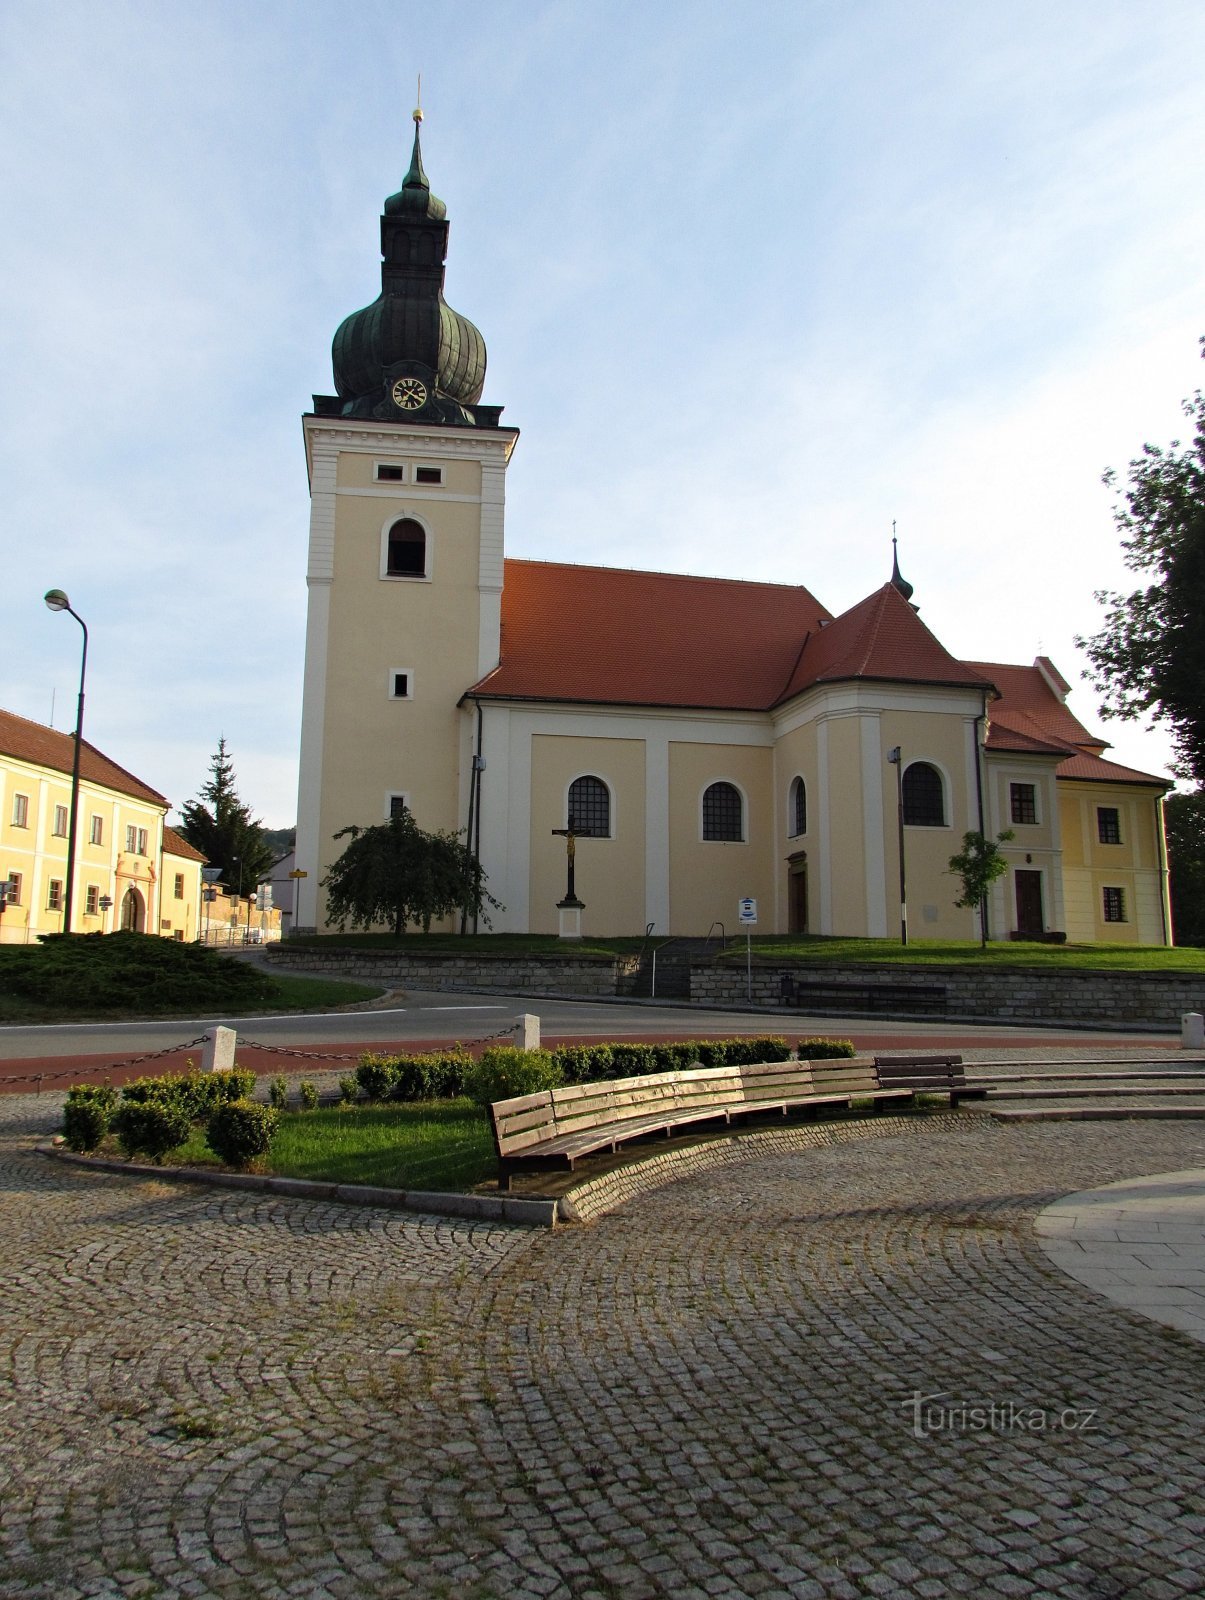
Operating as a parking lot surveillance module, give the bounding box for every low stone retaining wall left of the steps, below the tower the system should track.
[264,942,637,1000]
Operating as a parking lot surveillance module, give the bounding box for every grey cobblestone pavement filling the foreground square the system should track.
[0,1096,1205,1600]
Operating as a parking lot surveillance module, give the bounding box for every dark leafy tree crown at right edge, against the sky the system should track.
[1075,358,1205,782]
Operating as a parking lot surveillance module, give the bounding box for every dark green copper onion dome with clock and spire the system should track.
[331,110,498,427]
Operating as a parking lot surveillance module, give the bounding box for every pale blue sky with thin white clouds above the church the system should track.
[0,0,1205,827]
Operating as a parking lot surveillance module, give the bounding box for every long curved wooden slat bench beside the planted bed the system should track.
[490,1056,914,1189]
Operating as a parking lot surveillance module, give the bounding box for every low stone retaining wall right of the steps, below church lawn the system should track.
[690,965,1205,1029]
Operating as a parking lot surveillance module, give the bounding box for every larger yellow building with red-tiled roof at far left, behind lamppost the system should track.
[0,712,205,944]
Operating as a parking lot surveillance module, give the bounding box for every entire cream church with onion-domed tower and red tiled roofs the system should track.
[296,124,1170,944]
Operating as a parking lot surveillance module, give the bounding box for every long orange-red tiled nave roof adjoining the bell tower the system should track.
[467,560,829,710]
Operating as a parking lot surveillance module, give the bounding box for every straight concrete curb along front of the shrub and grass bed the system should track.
[38,1144,558,1227]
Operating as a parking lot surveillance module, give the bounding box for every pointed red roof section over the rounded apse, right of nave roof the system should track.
[779,582,992,699]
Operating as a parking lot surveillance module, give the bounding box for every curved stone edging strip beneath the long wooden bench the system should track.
[558,1112,967,1222]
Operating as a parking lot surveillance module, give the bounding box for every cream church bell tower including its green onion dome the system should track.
[294,110,518,931]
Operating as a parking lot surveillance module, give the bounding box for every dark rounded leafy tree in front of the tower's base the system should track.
[322,811,498,936]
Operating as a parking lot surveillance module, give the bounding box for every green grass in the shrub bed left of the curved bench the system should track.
[144,1099,498,1190]
